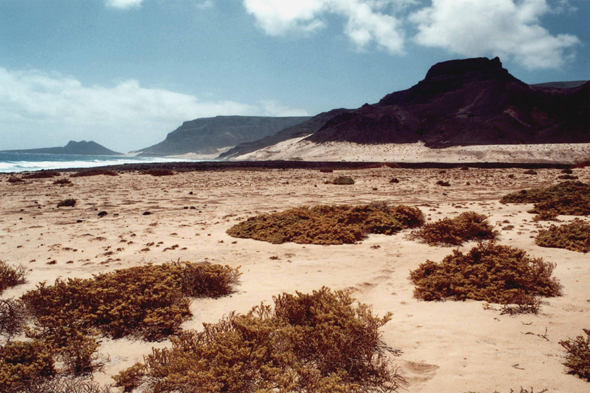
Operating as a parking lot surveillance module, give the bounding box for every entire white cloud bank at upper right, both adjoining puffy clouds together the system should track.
[243,0,580,69]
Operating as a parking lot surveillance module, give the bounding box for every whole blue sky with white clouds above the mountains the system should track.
[0,0,590,152]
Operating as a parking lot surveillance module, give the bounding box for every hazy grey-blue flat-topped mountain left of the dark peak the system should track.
[134,116,309,156]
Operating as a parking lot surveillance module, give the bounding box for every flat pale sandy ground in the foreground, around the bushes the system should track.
[0,167,590,393]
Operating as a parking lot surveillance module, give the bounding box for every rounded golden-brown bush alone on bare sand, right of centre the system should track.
[410,242,561,303]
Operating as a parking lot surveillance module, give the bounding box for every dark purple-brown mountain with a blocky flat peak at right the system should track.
[307,58,590,148]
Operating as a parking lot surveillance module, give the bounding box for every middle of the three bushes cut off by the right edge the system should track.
[535,219,590,253]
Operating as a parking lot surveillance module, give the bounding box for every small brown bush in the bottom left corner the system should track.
[0,341,56,393]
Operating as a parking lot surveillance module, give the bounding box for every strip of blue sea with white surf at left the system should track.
[0,152,204,173]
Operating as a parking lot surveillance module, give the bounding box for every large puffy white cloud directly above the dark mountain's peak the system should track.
[410,0,580,69]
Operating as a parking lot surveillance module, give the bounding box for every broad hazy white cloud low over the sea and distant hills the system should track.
[0,68,306,151]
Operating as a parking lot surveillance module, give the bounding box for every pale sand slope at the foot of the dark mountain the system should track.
[234,137,590,164]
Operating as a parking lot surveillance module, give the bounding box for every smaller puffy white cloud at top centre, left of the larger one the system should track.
[244,0,413,53]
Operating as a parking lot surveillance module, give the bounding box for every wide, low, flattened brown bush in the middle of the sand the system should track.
[227,205,424,244]
